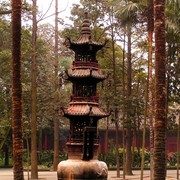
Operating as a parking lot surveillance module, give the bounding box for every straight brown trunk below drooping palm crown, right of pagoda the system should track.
[126,25,132,175]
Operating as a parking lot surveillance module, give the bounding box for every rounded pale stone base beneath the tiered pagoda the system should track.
[57,159,108,180]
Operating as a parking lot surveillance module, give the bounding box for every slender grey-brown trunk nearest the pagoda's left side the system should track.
[53,0,59,171]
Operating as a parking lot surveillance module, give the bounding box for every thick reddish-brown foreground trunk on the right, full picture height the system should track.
[154,0,167,180]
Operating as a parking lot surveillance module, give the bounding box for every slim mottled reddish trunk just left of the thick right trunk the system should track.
[147,0,154,180]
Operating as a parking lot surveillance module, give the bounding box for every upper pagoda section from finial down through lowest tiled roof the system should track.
[63,13,109,119]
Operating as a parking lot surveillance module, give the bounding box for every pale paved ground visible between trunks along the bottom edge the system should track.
[0,169,177,180]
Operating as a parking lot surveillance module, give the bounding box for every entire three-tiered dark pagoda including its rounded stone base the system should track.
[57,13,108,180]
